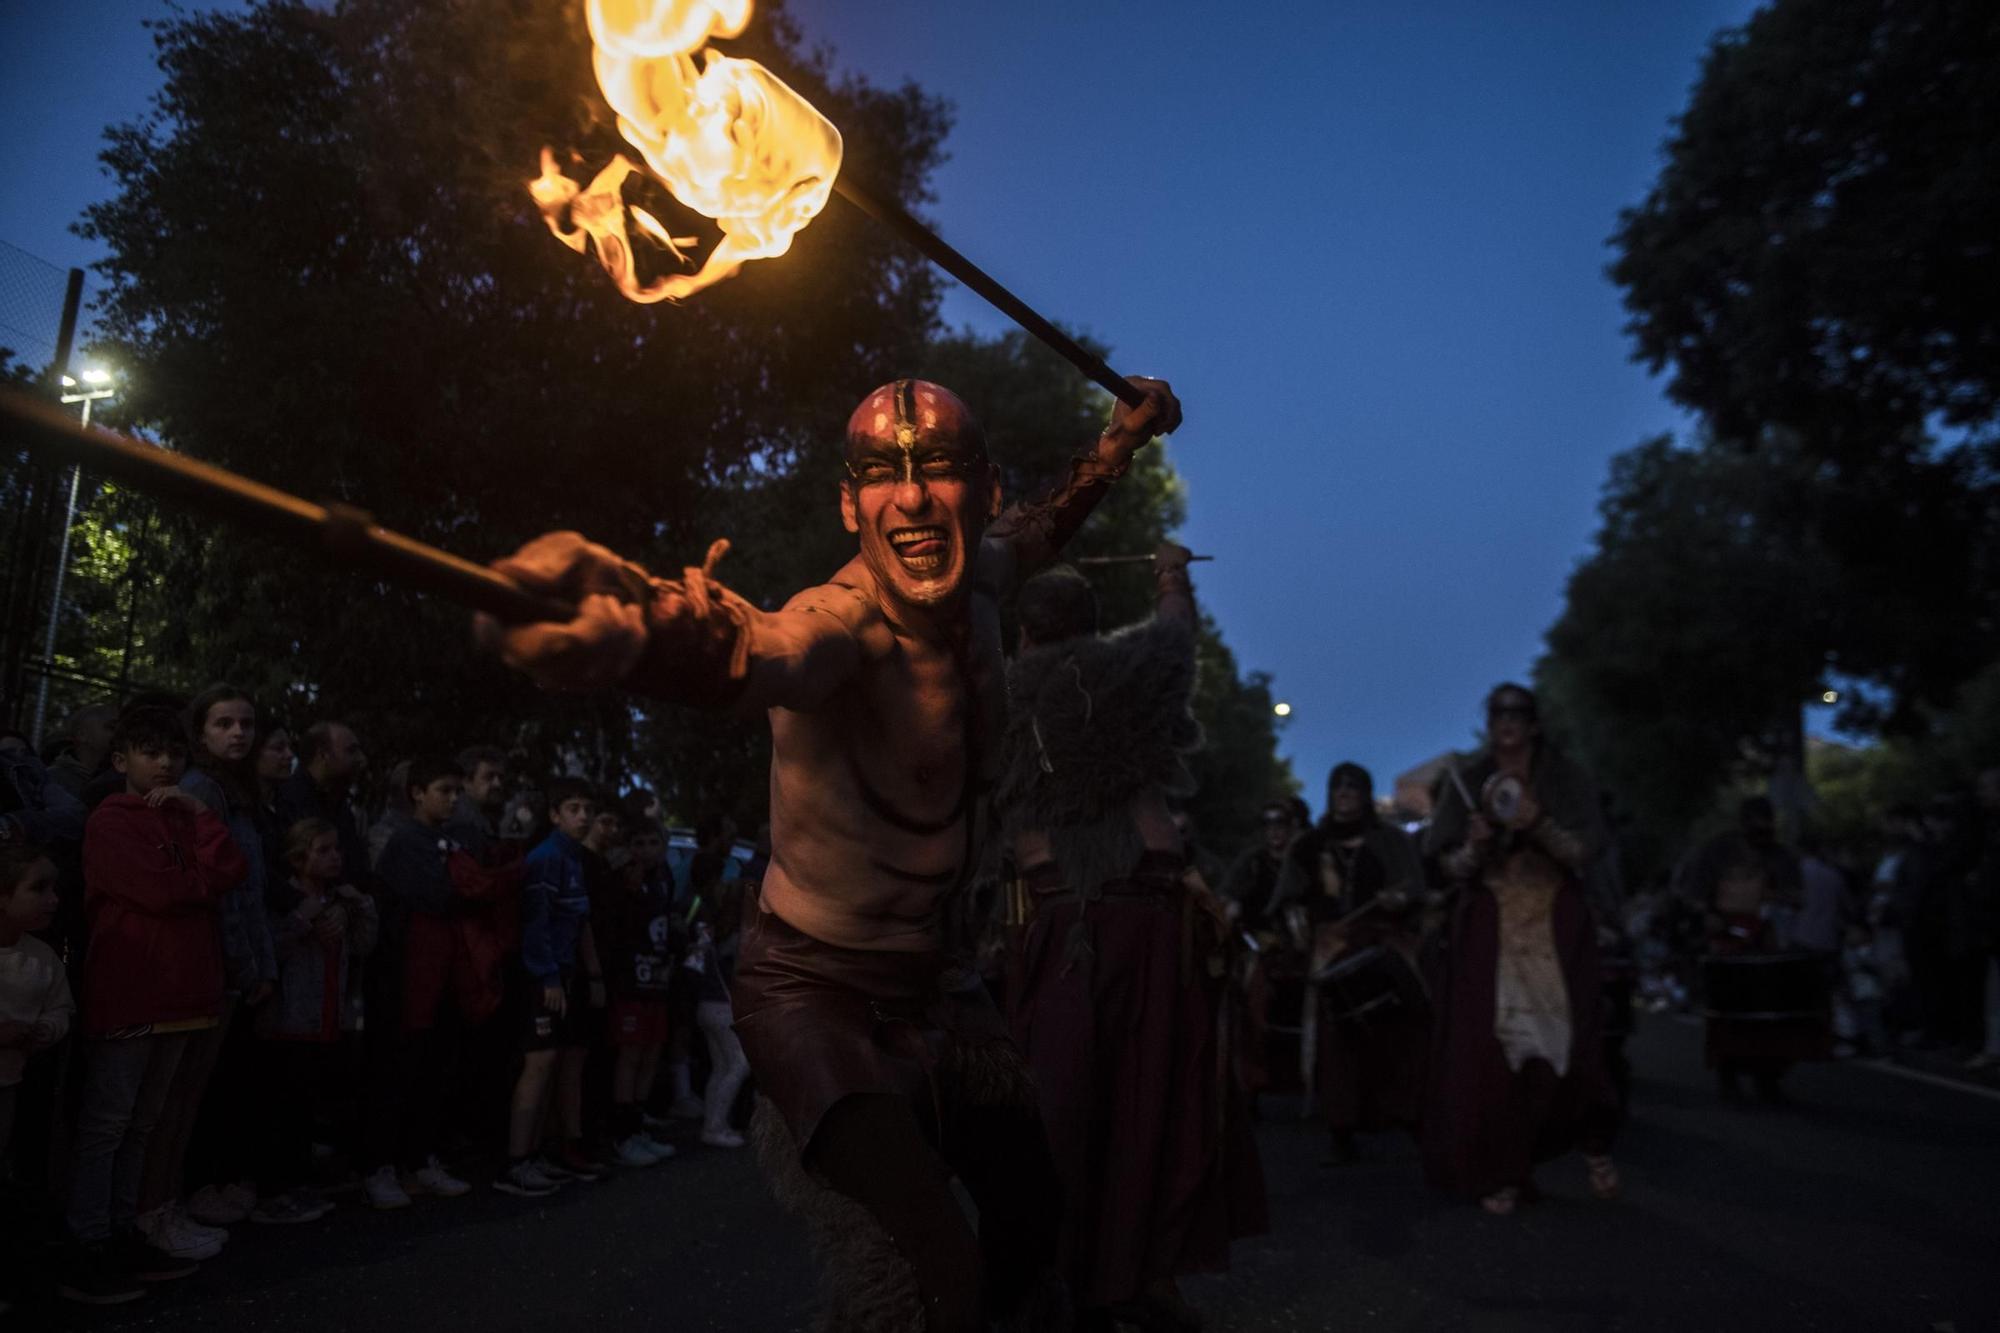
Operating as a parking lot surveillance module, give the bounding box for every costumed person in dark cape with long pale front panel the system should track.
[1422,685,1618,1213]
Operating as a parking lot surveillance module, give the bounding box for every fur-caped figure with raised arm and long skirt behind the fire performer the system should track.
[994,544,1264,1327]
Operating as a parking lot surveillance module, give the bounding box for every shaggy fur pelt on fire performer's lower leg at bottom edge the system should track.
[750,1097,924,1333]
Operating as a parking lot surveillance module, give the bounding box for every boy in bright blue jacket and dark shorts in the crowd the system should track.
[494,777,604,1199]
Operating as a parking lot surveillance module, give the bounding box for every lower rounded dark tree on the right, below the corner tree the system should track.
[1536,426,1992,876]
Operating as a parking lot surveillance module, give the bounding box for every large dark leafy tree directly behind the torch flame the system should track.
[80,0,946,769]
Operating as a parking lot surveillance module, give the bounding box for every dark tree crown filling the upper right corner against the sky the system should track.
[1610,0,2000,458]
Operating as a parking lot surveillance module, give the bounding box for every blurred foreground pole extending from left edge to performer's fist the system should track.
[0,390,576,624]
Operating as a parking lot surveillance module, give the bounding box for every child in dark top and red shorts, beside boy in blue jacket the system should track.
[590,817,680,1167]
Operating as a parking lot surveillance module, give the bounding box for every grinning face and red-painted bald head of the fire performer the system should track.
[840,380,1000,606]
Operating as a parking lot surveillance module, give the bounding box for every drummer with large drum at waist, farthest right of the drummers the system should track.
[1676,797,1830,1105]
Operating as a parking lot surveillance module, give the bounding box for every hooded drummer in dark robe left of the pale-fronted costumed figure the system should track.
[1278,763,1430,1165]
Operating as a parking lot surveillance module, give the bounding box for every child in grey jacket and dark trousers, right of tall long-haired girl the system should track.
[250,819,378,1223]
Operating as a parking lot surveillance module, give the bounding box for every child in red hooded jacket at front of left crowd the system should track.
[62,707,250,1303]
